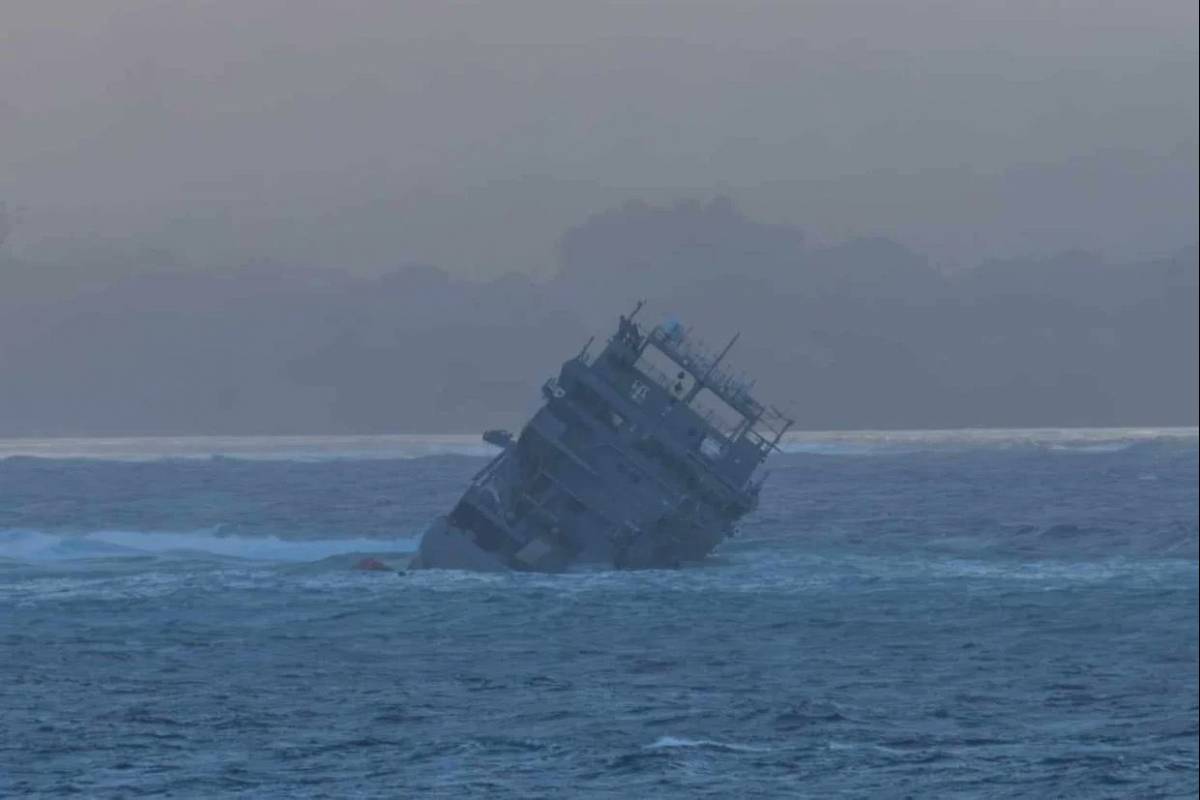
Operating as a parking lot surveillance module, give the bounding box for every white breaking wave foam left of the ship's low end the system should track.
[0,529,416,563]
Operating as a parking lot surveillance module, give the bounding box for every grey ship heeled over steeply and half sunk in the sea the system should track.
[412,302,792,571]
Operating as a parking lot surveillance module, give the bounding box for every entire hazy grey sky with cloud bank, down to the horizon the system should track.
[0,0,1198,435]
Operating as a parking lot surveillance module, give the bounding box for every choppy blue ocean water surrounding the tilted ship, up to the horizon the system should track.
[0,429,1200,798]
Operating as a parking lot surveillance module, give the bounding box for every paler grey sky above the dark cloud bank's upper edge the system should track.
[0,0,1198,275]
